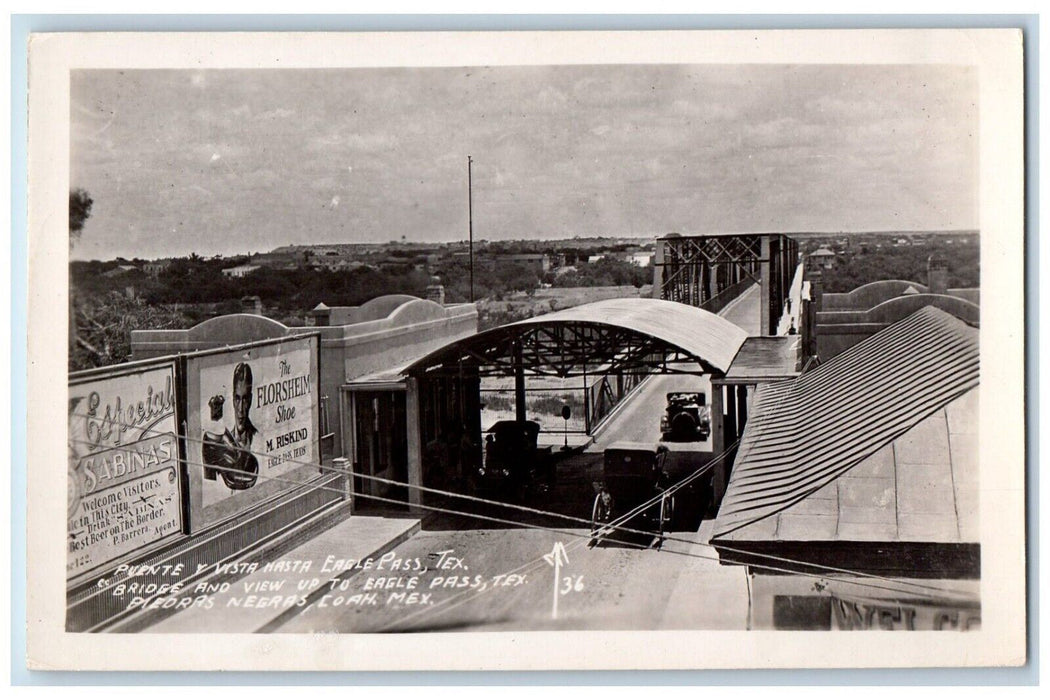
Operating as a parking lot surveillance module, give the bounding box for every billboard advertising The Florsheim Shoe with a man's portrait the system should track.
[186,335,320,532]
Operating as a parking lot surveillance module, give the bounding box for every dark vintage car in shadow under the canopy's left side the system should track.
[471,421,554,502]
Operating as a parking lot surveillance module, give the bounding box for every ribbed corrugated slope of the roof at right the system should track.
[714,306,979,537]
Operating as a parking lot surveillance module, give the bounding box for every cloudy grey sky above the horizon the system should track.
[70,65,978,259]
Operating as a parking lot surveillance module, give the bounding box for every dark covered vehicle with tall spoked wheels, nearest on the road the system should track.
[591,442,674,544]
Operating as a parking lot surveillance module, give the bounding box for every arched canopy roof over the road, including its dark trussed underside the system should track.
[406,298,748,377]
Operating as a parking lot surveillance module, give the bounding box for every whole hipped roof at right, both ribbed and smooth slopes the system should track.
[713,306,980,542]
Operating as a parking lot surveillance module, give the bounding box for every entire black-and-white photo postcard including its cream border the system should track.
[24,29,1026,671]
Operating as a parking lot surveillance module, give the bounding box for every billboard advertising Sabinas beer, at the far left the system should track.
[66,361,183,581]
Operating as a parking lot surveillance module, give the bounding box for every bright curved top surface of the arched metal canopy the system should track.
[509,298,748,372]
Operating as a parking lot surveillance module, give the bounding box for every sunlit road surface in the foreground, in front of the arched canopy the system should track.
[268,529,748,634]
